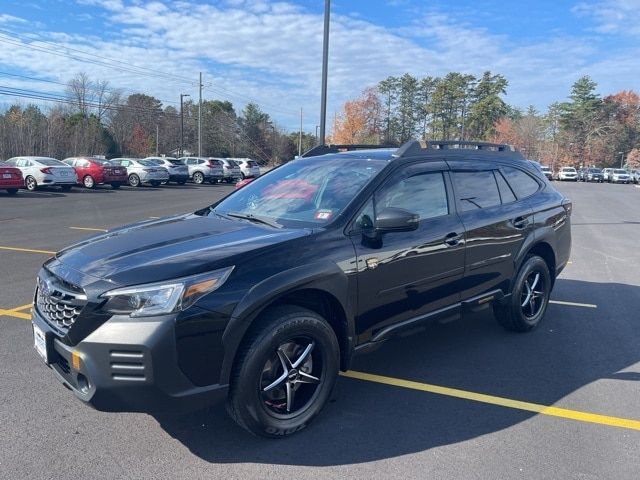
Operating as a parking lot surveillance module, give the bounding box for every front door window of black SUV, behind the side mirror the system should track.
[376,172,449,220]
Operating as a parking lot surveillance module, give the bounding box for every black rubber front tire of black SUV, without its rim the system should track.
[234,312,339,438]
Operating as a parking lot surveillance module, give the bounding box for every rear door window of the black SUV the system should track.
[453,170,501,212]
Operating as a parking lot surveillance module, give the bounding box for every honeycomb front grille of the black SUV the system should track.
[36,274,87,331]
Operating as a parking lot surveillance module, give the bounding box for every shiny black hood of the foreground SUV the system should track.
[56,214,310,286]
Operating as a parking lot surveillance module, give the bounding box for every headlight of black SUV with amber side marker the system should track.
[100,267,233,317]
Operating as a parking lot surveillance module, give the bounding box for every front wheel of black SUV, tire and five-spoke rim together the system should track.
[227,305,340,438]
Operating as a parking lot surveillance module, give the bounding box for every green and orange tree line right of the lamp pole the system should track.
[331,72,640,169]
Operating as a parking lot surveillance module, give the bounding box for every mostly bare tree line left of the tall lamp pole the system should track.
[0,73,315,163]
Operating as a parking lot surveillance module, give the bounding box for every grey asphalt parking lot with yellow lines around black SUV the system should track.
[0,182,640,479]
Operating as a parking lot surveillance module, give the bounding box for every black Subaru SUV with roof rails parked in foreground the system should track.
[33,142,571,437]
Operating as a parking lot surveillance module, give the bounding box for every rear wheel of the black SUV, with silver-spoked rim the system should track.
[493,255,551,332]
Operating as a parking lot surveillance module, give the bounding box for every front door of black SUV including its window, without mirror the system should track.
[351,162,464,342]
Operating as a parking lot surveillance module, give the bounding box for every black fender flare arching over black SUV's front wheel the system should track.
[220,261,355,383]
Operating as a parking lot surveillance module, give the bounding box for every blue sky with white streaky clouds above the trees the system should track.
[0,0,640,132]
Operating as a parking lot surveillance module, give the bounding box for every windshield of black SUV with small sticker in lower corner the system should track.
[212,157,387,226]
